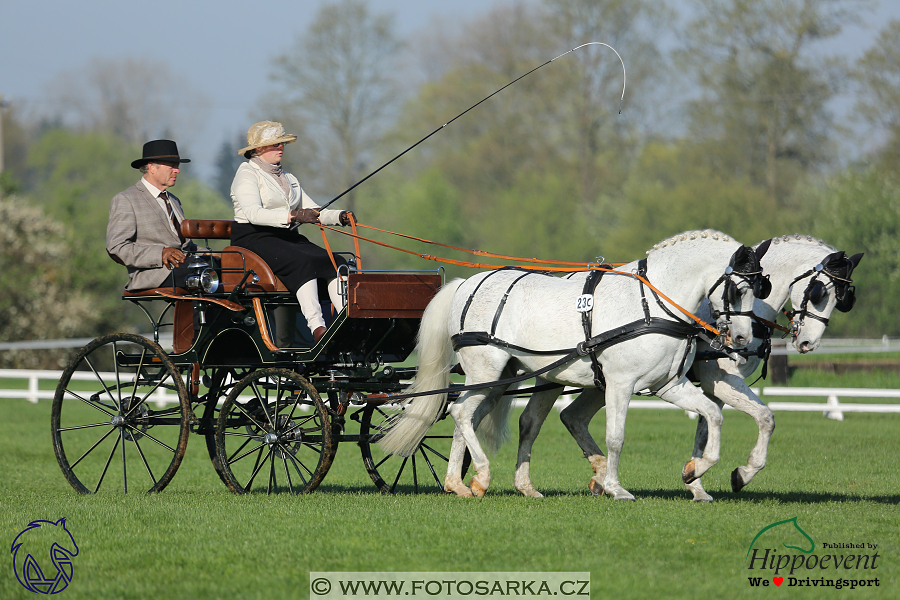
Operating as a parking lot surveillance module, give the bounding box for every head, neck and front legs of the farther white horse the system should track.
[686,234,863,502]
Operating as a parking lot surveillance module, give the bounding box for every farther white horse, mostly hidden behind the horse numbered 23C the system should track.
[515,234,862,502]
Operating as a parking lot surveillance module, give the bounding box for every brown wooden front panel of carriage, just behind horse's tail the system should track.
[347,273,441,319]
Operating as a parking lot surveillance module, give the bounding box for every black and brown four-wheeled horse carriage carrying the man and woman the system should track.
[51,219,464,494]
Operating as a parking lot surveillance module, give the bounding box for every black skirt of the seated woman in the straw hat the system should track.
[231,222,347,294]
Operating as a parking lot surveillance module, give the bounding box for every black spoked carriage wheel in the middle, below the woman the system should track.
[216,369,337,494]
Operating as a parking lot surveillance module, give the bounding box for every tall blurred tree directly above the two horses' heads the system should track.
[678,0,868,204]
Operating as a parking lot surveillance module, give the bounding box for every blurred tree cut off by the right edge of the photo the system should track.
[854,20,900,172]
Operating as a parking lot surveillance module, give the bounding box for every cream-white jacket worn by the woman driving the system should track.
[231,162,342,228]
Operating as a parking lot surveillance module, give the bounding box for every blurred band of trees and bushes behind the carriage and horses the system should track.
[0,0,900,367]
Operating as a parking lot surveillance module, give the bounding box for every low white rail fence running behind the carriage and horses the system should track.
[0,369,900,421]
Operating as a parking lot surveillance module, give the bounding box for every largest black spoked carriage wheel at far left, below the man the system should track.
[50,333,192,494]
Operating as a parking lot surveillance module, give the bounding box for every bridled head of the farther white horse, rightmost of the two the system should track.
[788,251,863,354]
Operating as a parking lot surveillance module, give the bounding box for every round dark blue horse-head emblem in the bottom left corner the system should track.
[10,518,78,594]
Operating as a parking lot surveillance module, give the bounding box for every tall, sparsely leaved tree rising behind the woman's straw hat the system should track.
[271,0,402,210]
